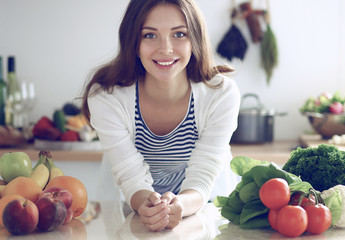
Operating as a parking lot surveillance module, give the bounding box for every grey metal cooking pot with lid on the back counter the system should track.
[231,93,286,144]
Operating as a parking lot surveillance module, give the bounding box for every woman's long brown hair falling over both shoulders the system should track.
[82,0,233,120]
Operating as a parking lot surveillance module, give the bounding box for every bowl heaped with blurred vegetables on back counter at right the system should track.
[300,92,345,139]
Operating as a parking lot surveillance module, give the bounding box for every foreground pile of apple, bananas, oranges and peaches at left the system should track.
[0,151,88,235]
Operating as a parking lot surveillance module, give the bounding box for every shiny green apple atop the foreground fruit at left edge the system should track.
[0,152,32,183]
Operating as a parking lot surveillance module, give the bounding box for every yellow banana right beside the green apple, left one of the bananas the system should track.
[30,151,49,189]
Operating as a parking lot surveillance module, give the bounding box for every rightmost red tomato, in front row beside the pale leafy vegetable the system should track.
[304,204,332,234]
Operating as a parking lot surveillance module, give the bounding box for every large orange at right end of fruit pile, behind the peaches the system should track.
[46,176,87,217]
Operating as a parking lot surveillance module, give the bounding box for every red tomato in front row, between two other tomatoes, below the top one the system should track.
[277,205,308,237]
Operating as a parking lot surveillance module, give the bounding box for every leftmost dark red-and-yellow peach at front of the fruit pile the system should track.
[3,198,39,235]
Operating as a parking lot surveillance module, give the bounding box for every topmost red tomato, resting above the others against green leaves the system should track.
[259,178,290,209]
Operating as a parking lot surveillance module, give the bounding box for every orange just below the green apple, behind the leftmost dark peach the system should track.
[2,177,42,203]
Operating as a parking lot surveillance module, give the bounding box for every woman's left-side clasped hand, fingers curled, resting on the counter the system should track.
[138,192,170,231]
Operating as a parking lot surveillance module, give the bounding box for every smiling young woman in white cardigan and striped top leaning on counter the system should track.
[83,0,240,231]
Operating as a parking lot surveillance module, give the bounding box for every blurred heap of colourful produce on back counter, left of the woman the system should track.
[32,103,97,142]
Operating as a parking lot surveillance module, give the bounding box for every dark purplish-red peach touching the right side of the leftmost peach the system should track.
[36,196,67,232]
